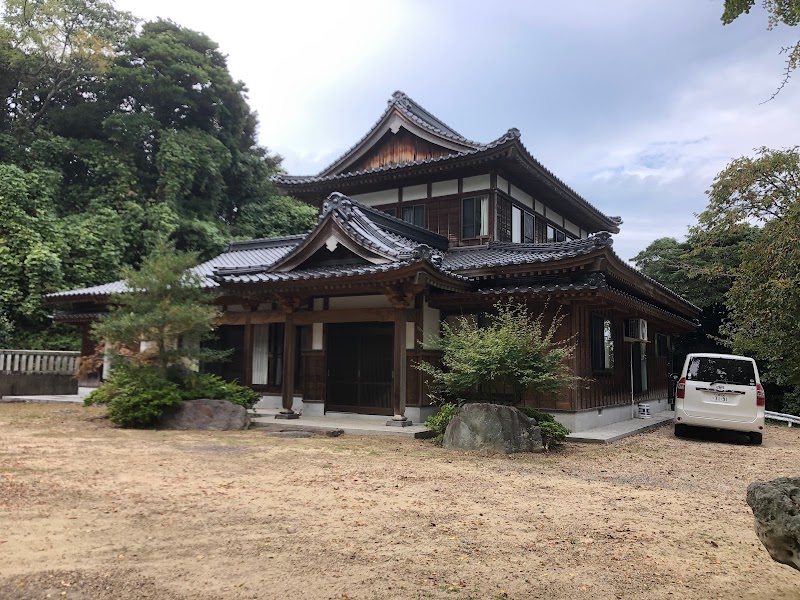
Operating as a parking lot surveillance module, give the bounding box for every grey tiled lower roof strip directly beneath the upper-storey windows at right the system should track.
[442,231,612,271]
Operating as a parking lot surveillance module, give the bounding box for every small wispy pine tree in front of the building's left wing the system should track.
[93,244,225,379]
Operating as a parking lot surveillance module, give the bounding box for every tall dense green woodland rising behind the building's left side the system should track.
[0,0,316,349]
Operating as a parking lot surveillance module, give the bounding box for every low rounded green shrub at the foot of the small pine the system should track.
[84,362,181,427]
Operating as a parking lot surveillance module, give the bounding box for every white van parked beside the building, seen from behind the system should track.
[674,353,765,444]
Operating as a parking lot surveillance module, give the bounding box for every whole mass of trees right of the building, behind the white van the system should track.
[633,147,800,411]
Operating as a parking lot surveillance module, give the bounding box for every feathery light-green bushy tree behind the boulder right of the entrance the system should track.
[416,303,577,404]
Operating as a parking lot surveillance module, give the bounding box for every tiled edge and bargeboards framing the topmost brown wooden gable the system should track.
[318,91,485,177]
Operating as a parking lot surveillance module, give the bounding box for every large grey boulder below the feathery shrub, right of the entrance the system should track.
[442,404,544,454]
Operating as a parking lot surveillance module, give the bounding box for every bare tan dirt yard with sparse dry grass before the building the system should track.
[0,404,800,600]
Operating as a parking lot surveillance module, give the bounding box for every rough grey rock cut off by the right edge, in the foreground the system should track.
[747,477,800,571]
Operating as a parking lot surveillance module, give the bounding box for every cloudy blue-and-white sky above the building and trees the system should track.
[116,0,800,259]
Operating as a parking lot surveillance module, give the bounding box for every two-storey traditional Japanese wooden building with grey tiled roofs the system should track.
[48,92,699,430]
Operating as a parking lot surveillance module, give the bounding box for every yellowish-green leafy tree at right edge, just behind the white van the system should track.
[694,147,800,386]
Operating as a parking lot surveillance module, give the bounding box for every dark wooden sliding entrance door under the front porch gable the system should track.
[326,323,394,415]
